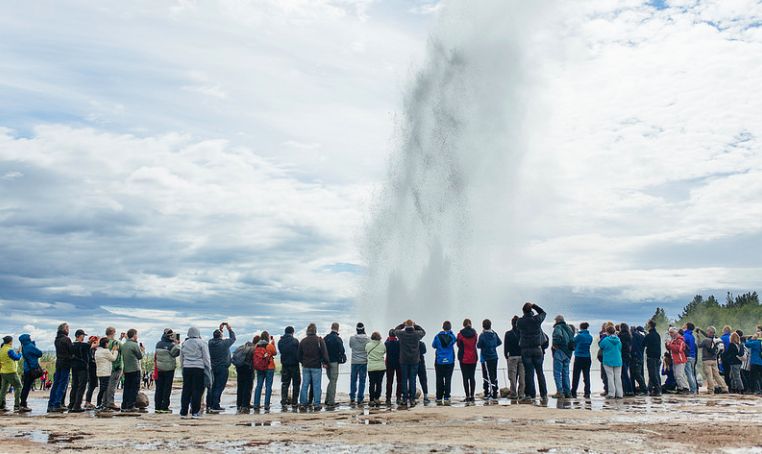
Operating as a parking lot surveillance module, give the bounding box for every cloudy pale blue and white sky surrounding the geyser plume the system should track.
[0,0,762,345]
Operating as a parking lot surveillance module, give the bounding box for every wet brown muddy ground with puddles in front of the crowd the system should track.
[0,396,762,454]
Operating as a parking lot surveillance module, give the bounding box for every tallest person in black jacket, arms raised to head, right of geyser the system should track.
[516,303,548,404]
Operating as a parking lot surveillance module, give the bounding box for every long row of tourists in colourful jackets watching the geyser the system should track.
[0,303,762,418]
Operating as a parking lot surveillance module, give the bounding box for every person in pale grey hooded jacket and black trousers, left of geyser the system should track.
[180,327,212,419]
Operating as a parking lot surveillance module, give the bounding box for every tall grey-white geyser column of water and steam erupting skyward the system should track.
[361,0,539,330]
